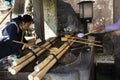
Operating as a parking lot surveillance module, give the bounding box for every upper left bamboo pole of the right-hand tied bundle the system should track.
[34,42,69,72]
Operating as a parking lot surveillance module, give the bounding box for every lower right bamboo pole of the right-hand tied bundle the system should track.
[34,42,74,80]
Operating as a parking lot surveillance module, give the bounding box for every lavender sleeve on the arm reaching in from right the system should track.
[105,19,120,32]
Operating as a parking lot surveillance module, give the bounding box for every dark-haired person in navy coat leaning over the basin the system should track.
[0,14,33,59]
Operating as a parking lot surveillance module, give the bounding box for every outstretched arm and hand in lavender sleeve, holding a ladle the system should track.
[97,19,120,36]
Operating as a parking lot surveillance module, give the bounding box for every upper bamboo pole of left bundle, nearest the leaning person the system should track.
[12,38,56,66]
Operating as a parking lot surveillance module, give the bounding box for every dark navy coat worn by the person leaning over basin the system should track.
[0,18,26,59]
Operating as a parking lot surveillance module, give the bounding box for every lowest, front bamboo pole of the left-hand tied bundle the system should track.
[8,37,55,75]
